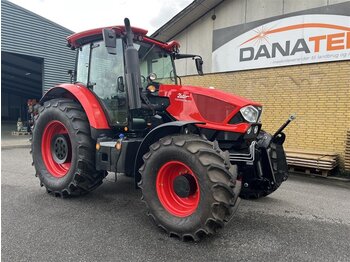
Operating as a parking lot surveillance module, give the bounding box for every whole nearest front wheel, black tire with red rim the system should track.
[139,135,240,241]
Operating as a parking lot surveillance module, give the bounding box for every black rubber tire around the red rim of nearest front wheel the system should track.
[139,135,240,241]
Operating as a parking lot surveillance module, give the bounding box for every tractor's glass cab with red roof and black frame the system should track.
[67,26,198,128]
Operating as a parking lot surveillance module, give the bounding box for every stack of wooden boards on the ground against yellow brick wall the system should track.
[286,149,338,176]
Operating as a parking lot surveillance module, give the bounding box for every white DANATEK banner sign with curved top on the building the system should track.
[212,14,350,72]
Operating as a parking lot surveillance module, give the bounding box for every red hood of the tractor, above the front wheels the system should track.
[159,85,262,133]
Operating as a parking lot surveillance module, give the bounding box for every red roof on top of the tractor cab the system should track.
[66,25,180,51]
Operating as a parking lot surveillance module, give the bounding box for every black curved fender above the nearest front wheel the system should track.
[134,121,204,186]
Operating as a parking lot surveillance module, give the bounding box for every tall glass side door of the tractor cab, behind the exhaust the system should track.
[77,38,128,126]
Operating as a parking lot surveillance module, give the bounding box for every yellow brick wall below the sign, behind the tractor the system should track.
[182,61,350,168]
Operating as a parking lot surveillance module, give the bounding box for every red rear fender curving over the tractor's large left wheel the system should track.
[40,84,111,139]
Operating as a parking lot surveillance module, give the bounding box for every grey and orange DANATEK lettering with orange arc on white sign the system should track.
[239,23,350,62]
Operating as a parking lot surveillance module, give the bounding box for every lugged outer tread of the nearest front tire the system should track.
[139,135,238,241]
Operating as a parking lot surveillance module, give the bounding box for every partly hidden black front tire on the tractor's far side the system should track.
[239,130,288,199]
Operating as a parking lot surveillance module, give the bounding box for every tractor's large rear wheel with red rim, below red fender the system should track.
[31,98,106,197]
